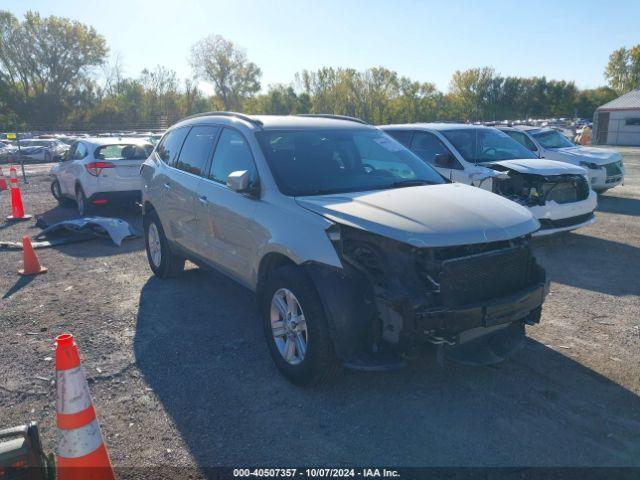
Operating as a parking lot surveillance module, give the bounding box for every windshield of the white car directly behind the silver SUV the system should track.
[442,128,538,163]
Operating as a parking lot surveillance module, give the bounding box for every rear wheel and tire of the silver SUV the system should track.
[143,211,185,278]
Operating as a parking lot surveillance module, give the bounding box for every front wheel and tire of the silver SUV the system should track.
[260,266,341,386]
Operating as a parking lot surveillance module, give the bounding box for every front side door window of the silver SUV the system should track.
[209,128,256,184]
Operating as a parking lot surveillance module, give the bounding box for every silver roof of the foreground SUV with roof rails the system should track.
[174,112,375,130]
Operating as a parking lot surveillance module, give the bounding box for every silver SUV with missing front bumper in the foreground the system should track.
[141,112,547,385]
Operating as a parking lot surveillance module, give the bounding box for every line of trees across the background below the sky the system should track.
[0,10,640,131]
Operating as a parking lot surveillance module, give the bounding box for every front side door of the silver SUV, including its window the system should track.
[191,127,260,284]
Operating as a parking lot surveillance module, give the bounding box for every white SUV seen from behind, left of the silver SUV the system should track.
[50,138,153,216]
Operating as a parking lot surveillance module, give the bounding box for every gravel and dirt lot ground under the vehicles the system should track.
[0,152,640,476]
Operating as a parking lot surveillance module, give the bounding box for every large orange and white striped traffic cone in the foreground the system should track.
[56,333,115,480]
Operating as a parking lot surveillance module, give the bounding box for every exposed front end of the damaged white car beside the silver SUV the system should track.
[491,165,589,207]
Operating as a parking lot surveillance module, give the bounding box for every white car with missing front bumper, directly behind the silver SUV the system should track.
[381,124,597,236]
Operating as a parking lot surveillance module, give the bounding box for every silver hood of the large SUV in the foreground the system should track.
[296,183,540,247]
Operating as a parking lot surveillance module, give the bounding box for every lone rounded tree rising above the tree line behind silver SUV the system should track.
[190,35,262,110]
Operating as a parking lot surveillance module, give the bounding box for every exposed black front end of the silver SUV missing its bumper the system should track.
[341,223,545,354]
